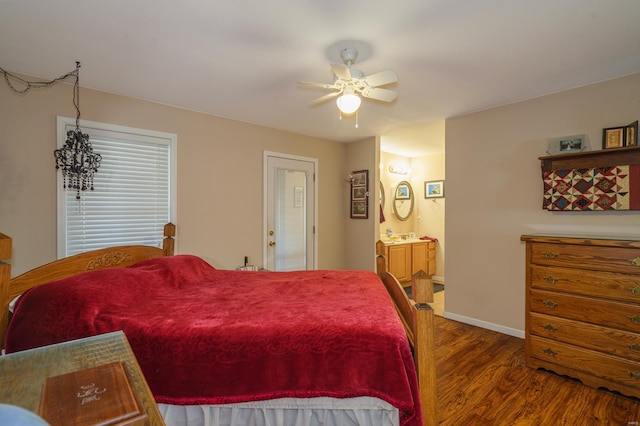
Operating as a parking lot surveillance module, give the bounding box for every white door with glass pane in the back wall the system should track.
[263,153,317,271]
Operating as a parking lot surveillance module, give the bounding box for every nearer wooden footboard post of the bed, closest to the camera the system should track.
[411,270,438,425]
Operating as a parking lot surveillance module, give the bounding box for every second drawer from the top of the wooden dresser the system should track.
[530,265,640,304]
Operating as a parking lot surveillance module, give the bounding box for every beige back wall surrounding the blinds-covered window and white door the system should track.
[0,77,356,276]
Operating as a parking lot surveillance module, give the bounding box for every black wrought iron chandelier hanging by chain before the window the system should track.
[53,62,102,200]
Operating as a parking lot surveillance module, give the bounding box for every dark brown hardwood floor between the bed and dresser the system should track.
[435,316,640,426]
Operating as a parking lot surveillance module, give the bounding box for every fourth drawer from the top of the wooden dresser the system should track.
[529,313,640,362]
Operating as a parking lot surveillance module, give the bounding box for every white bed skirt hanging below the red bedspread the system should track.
[158,397,400,426]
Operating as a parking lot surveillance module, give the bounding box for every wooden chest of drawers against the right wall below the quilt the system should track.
[521,235,640,397]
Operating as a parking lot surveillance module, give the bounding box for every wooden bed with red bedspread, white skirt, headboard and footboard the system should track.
[0,224,436,426]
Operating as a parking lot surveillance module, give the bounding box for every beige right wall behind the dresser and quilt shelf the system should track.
[445,74,640,335]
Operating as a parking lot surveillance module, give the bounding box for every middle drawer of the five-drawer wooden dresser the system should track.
[529,290,640,333]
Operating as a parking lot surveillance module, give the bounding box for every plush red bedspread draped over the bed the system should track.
[6,255,422,425]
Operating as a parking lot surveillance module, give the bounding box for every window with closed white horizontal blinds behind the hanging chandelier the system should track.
[57,117,177,258]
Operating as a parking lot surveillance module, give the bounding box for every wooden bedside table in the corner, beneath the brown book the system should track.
[0,331,165,426]
